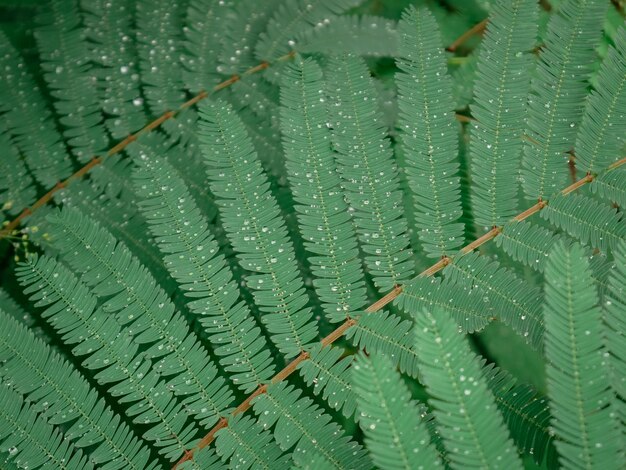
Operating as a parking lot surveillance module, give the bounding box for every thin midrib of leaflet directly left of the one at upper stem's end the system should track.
[215,114,305,352]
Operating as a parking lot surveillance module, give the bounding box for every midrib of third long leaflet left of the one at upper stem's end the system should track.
[56,217,220,416]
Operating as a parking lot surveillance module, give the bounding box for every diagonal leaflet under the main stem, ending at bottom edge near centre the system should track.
[253,382,371,470]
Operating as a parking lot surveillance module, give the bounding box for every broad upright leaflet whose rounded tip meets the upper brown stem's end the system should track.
[280,57,367,322]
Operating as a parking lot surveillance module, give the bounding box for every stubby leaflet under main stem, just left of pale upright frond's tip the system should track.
[298,345,359,420]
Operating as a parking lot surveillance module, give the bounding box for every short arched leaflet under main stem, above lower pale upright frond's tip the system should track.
[397,276,494,333]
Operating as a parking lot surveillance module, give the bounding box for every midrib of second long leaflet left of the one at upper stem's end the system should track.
[156,184,263,385]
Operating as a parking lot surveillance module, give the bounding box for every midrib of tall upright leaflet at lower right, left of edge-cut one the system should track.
[554,250,593,470]
